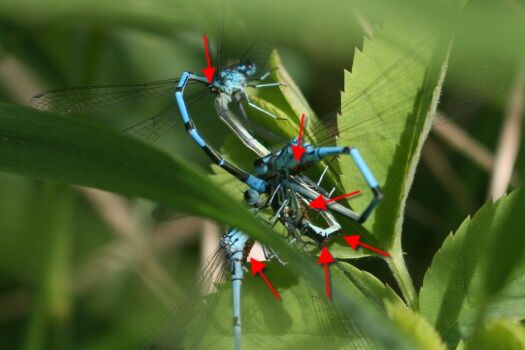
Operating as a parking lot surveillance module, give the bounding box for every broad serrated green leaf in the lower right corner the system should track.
[420,192,525,346]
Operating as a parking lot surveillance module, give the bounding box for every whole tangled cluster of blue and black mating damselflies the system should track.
[33,31,436,348]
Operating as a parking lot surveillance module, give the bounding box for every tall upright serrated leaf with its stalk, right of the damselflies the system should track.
[337,22,450,309]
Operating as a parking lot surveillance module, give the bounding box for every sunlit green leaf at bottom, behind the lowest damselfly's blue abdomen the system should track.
[188,264,375,349]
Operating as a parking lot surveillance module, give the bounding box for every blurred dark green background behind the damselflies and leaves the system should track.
[0,0,525,349]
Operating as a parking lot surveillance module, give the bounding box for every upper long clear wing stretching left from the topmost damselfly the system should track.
[30,78,191,113]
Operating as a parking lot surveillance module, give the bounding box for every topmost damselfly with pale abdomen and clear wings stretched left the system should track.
[30,34,280,156]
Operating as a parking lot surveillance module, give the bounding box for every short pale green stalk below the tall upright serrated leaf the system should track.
[386,244,419,311]
